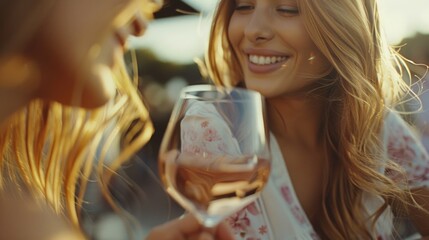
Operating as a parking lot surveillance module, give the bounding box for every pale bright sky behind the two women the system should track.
[129,0,429,63]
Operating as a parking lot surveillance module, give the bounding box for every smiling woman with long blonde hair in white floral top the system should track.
[207,0,429,240]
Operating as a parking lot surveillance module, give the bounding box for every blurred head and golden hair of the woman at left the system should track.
[0,0,159,228]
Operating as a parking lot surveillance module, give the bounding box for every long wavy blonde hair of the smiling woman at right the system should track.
[206,0,411,239]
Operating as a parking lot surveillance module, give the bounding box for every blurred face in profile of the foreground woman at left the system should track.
[26,0,153,108]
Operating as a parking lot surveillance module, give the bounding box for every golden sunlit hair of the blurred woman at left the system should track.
[0,0,161,229]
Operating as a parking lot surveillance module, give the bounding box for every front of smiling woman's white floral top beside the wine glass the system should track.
[226,134,319,240]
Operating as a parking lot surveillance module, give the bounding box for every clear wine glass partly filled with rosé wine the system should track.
[159,85,271,228]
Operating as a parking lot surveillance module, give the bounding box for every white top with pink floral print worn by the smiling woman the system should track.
[222,113,429,240]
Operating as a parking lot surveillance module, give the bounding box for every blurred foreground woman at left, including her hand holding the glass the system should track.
[0,0,231,239]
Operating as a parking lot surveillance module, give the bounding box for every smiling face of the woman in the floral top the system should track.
[228,0,330,97]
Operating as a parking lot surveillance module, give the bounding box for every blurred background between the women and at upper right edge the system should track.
[85,0,429,240]
